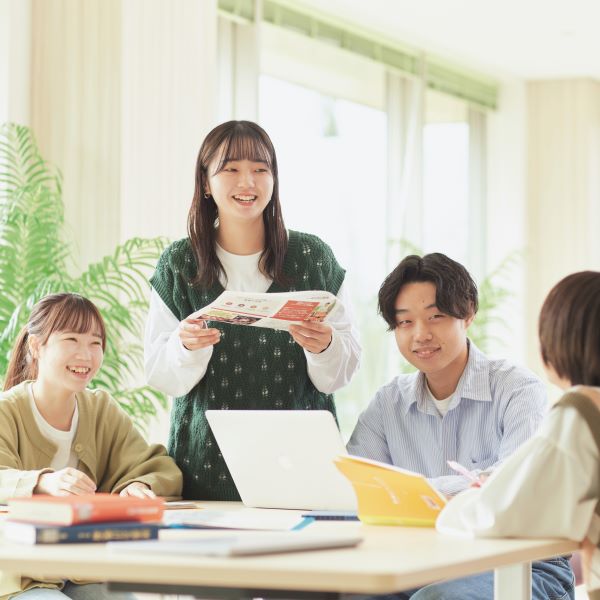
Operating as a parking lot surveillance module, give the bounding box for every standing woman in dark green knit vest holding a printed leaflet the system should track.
[144,121,360,500]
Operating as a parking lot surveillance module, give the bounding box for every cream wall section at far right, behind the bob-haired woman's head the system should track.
[526,79,600,380]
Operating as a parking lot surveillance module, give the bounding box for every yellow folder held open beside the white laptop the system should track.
[334,455,446,527]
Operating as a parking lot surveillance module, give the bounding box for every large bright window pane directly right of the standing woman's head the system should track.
[260,76,386,300]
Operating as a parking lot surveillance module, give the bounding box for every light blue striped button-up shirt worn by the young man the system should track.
[347,342,548,495]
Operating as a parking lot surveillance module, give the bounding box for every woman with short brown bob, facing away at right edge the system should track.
[437,271,600,600]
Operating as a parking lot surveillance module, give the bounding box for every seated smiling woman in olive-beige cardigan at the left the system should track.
[0,294,182,600]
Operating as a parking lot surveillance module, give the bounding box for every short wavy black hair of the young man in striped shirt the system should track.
[379,252,479,331]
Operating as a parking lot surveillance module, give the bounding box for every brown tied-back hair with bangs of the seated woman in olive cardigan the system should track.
[4,293,106,391]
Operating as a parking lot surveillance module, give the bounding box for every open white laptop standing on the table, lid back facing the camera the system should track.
[206,410,357,510]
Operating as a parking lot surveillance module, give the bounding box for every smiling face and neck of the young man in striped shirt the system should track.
[394,282,473,397]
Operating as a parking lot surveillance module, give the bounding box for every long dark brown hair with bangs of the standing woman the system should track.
[188,121,287,287]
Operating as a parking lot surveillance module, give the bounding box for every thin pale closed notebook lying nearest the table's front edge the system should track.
[107,532,362,556]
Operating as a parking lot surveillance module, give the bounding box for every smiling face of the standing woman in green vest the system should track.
[206,156,274,222]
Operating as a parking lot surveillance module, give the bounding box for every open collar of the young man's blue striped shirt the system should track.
[398,340,492,416]
